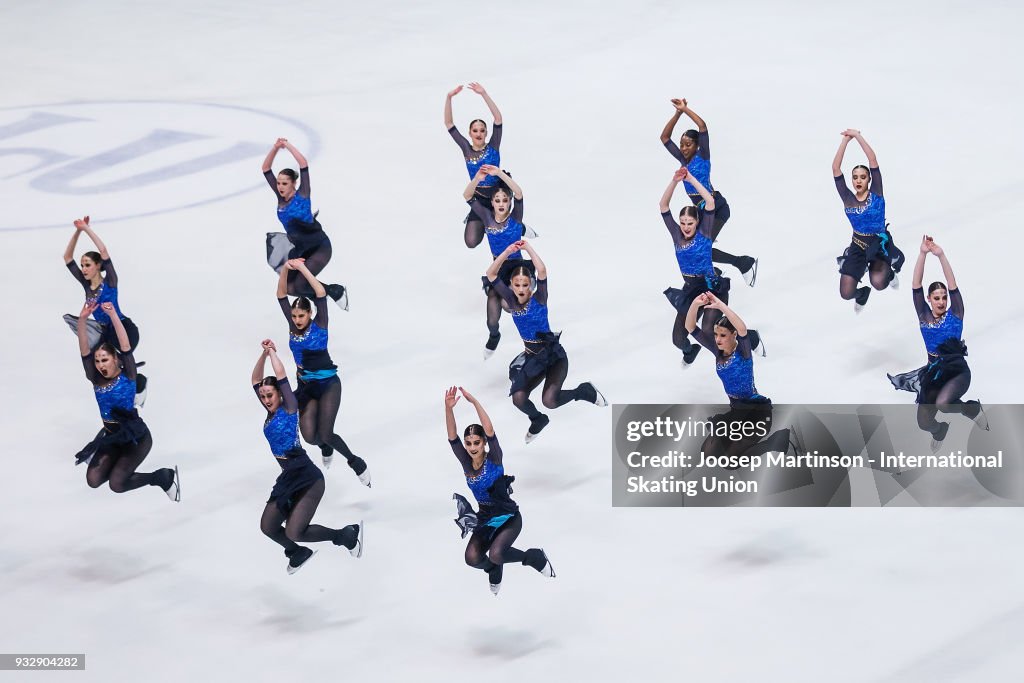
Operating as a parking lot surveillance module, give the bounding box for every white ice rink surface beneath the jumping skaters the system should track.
[0,0,1024,683]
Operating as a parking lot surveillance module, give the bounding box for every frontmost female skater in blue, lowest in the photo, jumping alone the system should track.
[444,387,555,595]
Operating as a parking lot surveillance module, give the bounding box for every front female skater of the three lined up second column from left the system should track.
[252,339,362,573]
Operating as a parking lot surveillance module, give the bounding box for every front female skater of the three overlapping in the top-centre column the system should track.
[486,241,608,443]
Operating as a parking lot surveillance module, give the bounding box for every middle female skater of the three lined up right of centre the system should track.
[659,167,763,368]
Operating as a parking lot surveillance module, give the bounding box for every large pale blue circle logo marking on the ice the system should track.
[0,100,321,231]
